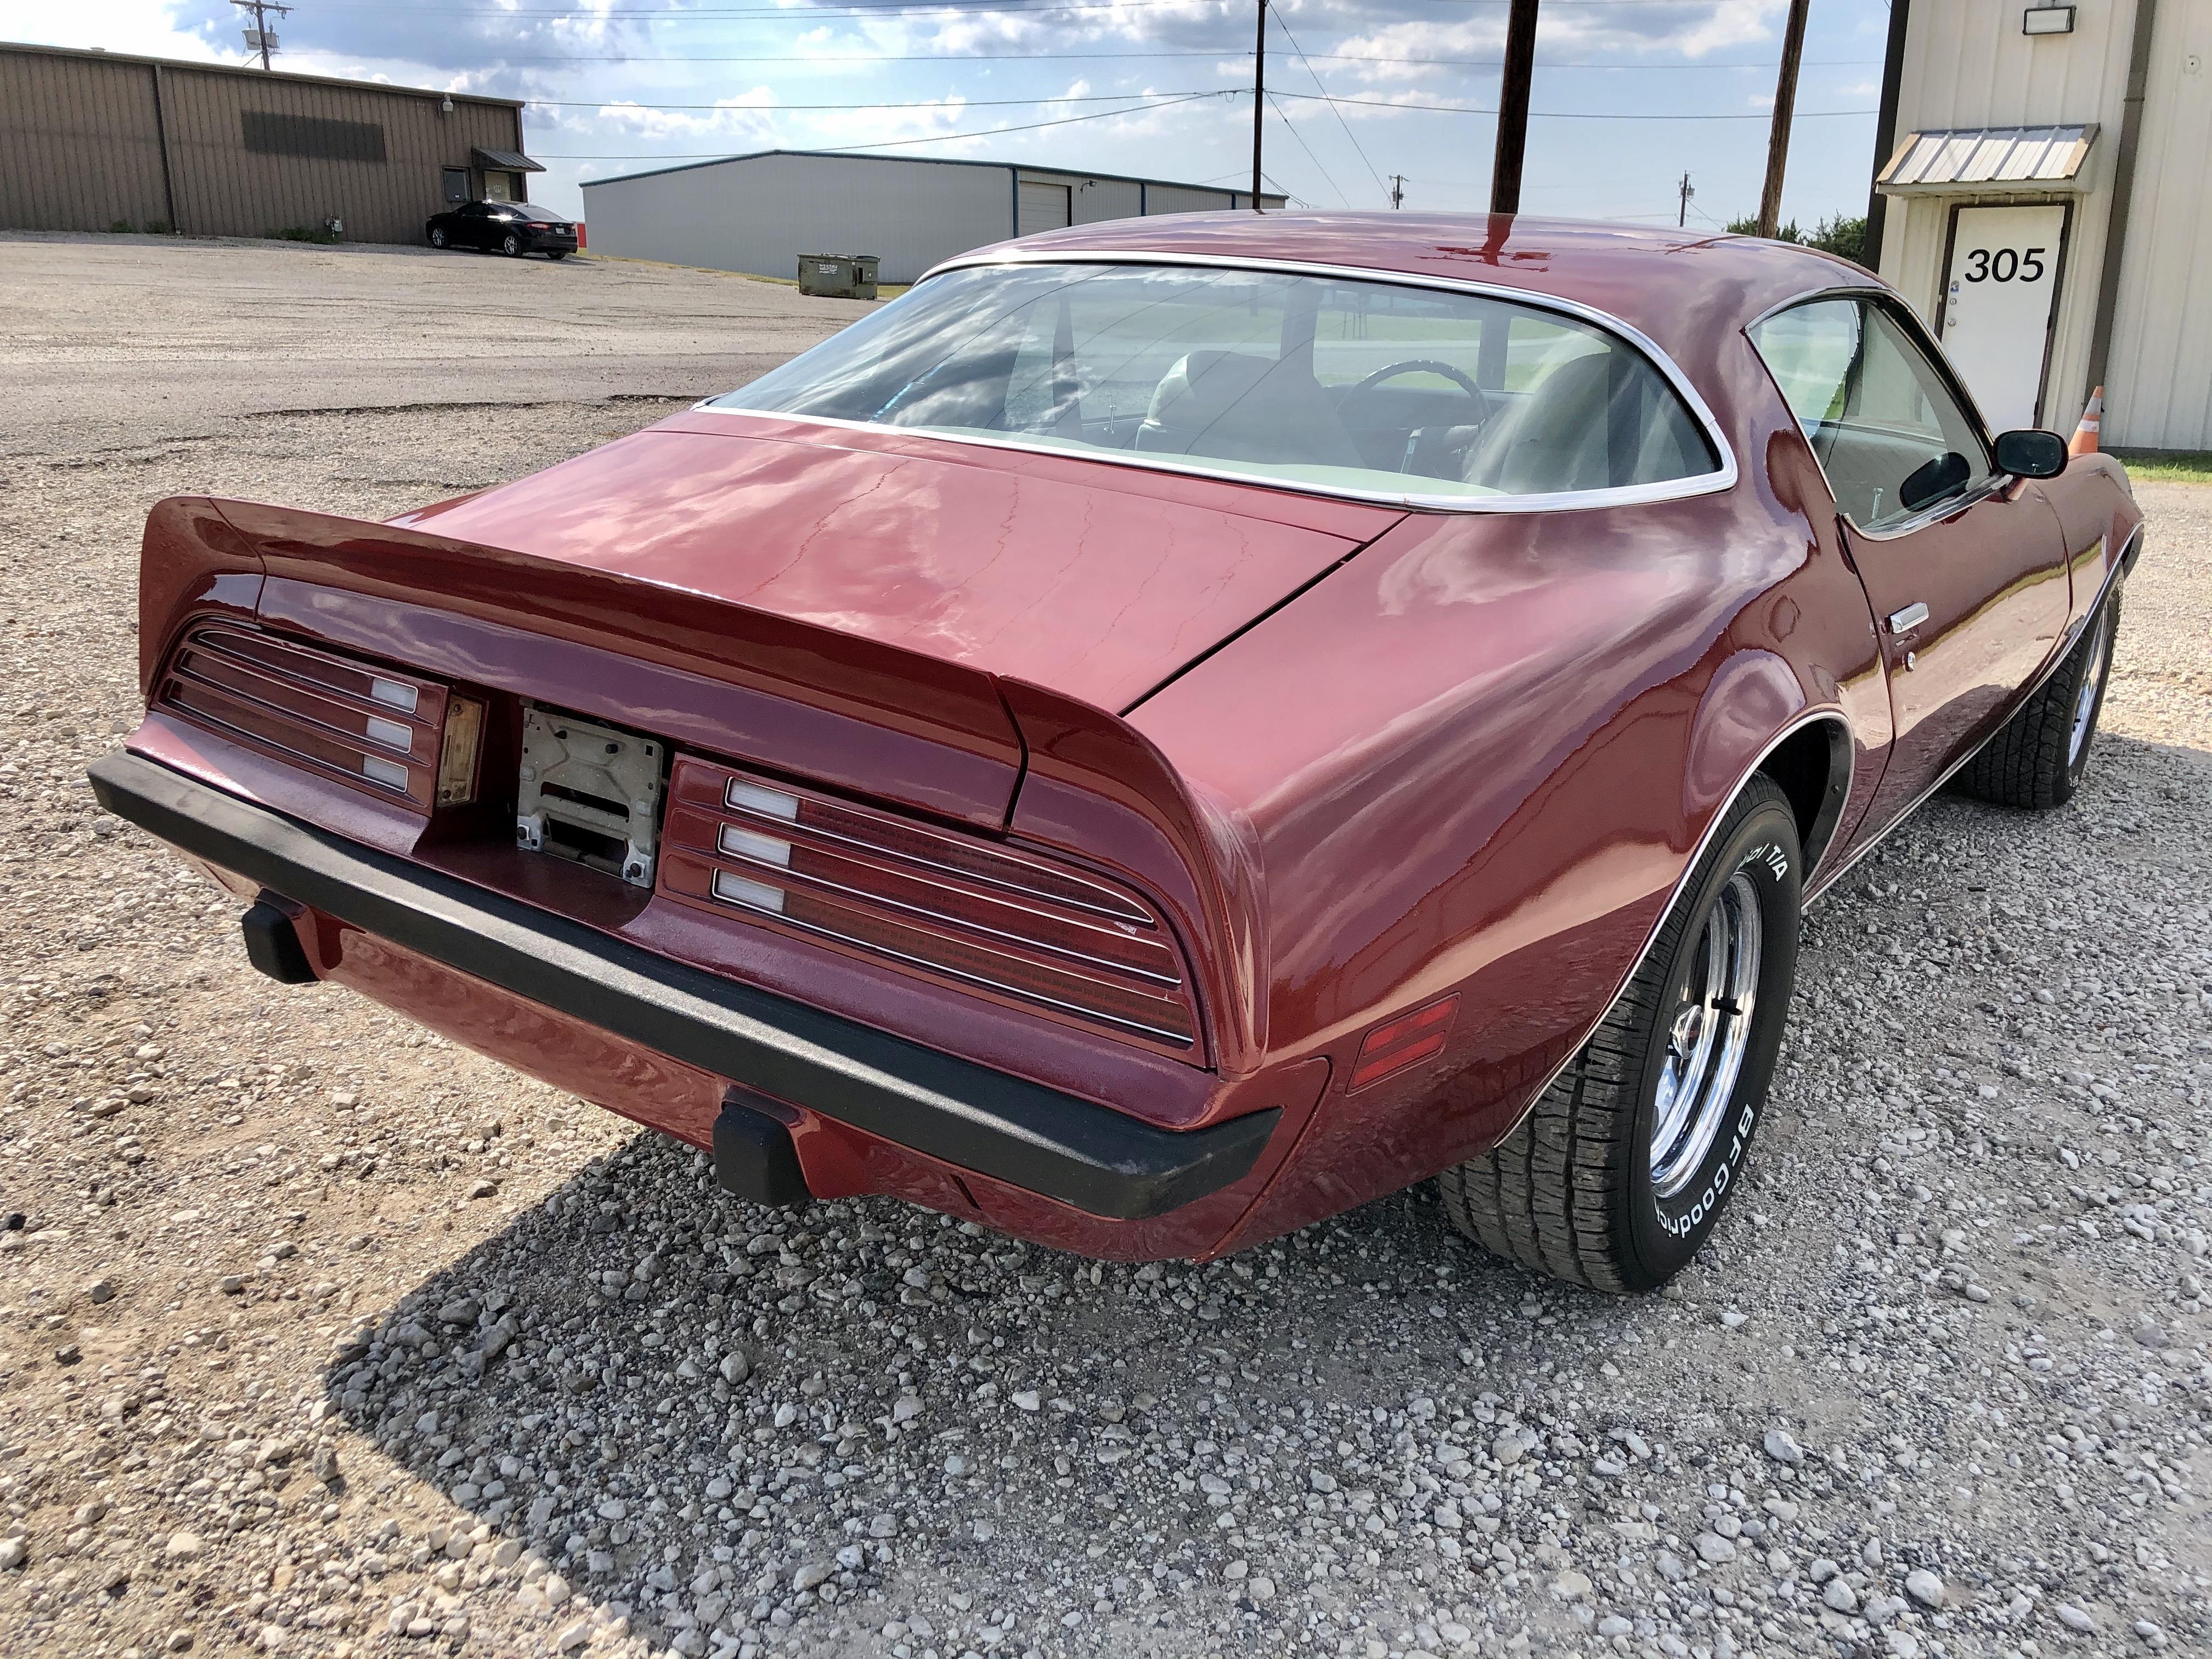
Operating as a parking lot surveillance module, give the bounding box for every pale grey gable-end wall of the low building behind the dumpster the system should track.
[584,155,1013,283]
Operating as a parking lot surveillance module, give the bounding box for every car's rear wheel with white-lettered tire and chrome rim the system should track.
[1438,776,1805,1292]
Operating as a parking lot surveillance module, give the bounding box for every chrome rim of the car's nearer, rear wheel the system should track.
[1652,872,1765,1199]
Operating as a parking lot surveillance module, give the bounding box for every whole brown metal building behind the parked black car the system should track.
[0,42,544,244]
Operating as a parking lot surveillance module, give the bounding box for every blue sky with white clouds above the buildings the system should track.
[0,0,1889,225]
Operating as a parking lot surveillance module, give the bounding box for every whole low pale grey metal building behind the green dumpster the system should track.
[584,150,1283,283]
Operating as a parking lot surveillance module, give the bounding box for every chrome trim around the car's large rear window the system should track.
[695,248,1741,513]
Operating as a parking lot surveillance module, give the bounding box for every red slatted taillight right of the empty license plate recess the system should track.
[662,757,1197,1053]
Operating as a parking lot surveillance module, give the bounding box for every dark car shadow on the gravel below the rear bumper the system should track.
[325,1132,1630,1652]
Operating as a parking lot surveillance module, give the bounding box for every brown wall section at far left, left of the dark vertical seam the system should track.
[0,51,170,230]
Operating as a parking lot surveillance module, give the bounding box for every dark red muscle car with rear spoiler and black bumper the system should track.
[93,215,2141,1290]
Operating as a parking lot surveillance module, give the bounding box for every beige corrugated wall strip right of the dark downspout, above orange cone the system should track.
[2101,0,2212,449]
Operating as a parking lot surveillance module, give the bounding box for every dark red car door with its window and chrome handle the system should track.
[1752,294,2068,830]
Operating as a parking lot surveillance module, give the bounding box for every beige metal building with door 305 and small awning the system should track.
[1874,0,2212,449]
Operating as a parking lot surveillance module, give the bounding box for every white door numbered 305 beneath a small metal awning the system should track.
[1938,204,2066,431]
